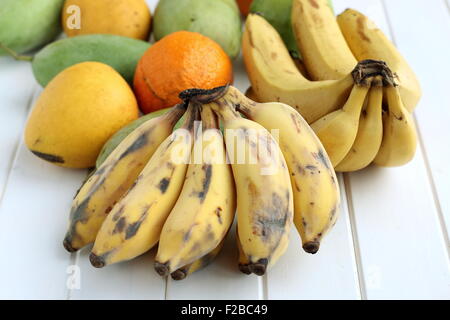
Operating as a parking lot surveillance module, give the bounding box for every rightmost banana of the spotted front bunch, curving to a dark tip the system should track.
[230,87,340,253]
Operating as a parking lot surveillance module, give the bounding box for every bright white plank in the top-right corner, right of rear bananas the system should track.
[385,0,450,252]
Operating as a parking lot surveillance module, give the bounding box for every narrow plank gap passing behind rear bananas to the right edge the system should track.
[381,0,450,255]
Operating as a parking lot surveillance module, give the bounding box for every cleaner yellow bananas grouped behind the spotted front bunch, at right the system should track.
[243,0,420,172]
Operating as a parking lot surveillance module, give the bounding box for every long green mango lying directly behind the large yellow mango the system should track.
[32,34,150,87]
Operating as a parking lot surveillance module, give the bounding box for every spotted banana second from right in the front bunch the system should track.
[184,87,293,275]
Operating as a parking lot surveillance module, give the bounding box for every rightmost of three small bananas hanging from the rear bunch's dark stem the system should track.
[374,85,417,167]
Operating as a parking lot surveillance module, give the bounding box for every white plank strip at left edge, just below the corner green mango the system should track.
[0,56,35,201]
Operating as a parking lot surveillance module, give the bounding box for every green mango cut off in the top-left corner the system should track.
[0,0,64,55]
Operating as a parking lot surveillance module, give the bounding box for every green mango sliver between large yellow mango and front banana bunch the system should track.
[96,108,184,168]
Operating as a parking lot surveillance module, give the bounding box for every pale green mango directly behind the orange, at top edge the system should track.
[153,0,242,59]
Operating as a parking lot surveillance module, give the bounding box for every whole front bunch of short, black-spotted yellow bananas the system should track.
[64,86,340,280]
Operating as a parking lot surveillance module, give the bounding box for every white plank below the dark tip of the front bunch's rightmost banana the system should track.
[267,175,361,300]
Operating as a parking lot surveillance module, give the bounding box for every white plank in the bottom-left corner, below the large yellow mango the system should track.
[0,97,86,299]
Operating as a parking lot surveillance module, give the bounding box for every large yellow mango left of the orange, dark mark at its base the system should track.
[24,62,139,168]
